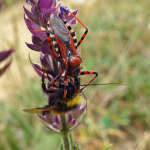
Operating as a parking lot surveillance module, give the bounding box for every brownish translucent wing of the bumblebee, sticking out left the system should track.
[23,105,57,114]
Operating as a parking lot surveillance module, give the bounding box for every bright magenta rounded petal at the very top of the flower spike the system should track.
[37,0,53,11]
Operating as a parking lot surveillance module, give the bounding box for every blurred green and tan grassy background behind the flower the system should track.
[0,0,150,150]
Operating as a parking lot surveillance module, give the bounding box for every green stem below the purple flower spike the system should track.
[61,114,71,150]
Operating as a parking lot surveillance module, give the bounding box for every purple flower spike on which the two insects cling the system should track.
[23,0,86,133]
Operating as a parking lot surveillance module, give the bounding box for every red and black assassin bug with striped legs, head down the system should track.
[33,12,98,98]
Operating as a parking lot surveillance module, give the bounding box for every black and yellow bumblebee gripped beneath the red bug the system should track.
[23,75,82,115]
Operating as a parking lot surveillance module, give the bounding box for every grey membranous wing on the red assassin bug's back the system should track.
[50,14,70,44]
